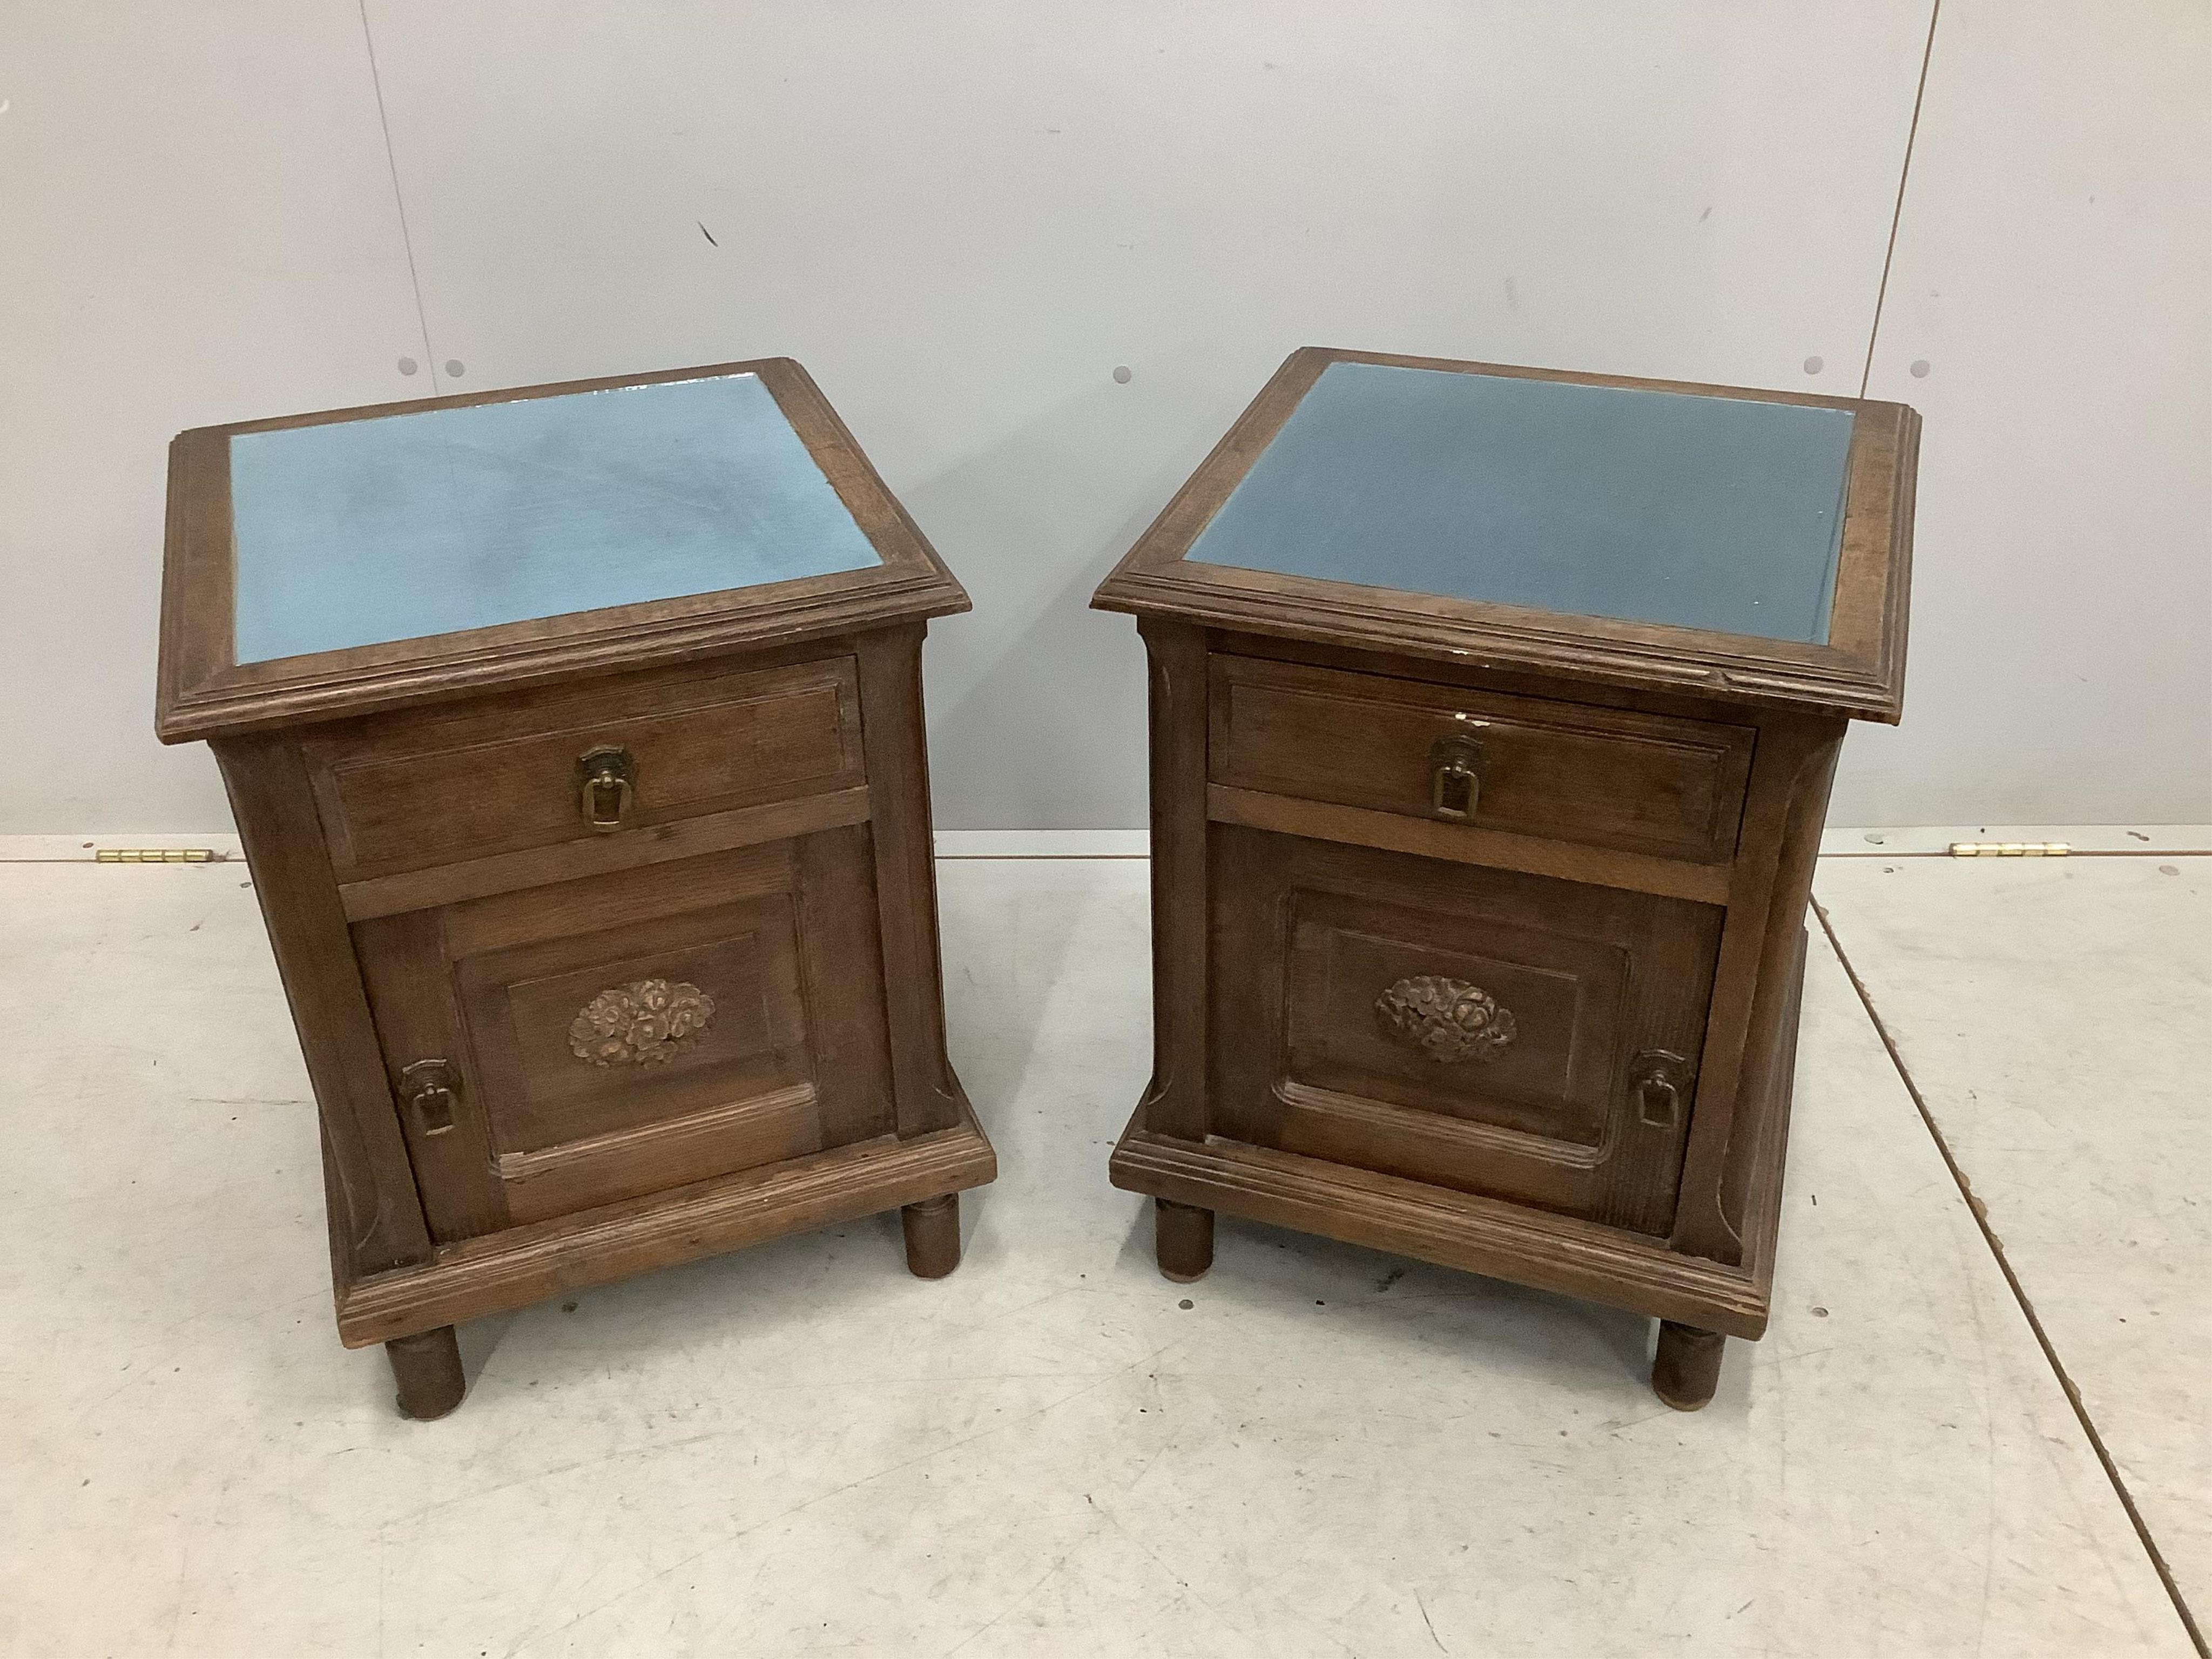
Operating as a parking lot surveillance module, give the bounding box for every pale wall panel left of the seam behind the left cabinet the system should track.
[0,0,424,834]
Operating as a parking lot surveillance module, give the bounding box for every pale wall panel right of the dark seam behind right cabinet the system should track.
[1858,0,2212,823]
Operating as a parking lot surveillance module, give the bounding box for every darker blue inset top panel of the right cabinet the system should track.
[1185,363,1853,644]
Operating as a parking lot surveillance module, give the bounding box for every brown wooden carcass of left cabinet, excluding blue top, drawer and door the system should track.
[155,359,995,1415]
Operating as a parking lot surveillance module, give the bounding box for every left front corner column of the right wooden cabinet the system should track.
[1137,617,1208,1150]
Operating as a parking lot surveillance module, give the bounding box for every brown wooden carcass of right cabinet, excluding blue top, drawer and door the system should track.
[1092,347,1920,1409]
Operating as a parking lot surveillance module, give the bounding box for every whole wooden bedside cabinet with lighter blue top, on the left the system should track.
[157,359,995,1418]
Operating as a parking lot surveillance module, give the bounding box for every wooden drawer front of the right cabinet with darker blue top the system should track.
[1208,655,1754,862]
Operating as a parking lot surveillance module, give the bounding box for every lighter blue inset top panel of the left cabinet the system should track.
[230,374,882,664]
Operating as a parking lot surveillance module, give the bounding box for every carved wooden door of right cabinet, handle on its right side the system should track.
[1208,825,1721,1235]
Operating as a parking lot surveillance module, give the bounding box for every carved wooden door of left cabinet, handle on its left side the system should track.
[354,825,894,1241]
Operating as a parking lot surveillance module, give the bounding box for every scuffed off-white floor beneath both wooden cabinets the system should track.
[0,858,2212,1659]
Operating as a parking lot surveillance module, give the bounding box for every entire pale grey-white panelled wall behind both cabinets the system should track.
[0,0,2212,832]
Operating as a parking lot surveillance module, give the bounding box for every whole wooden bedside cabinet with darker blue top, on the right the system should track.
[1095,349,1920,1409]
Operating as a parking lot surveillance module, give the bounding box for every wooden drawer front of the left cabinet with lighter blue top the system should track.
[301,657,865,880]
